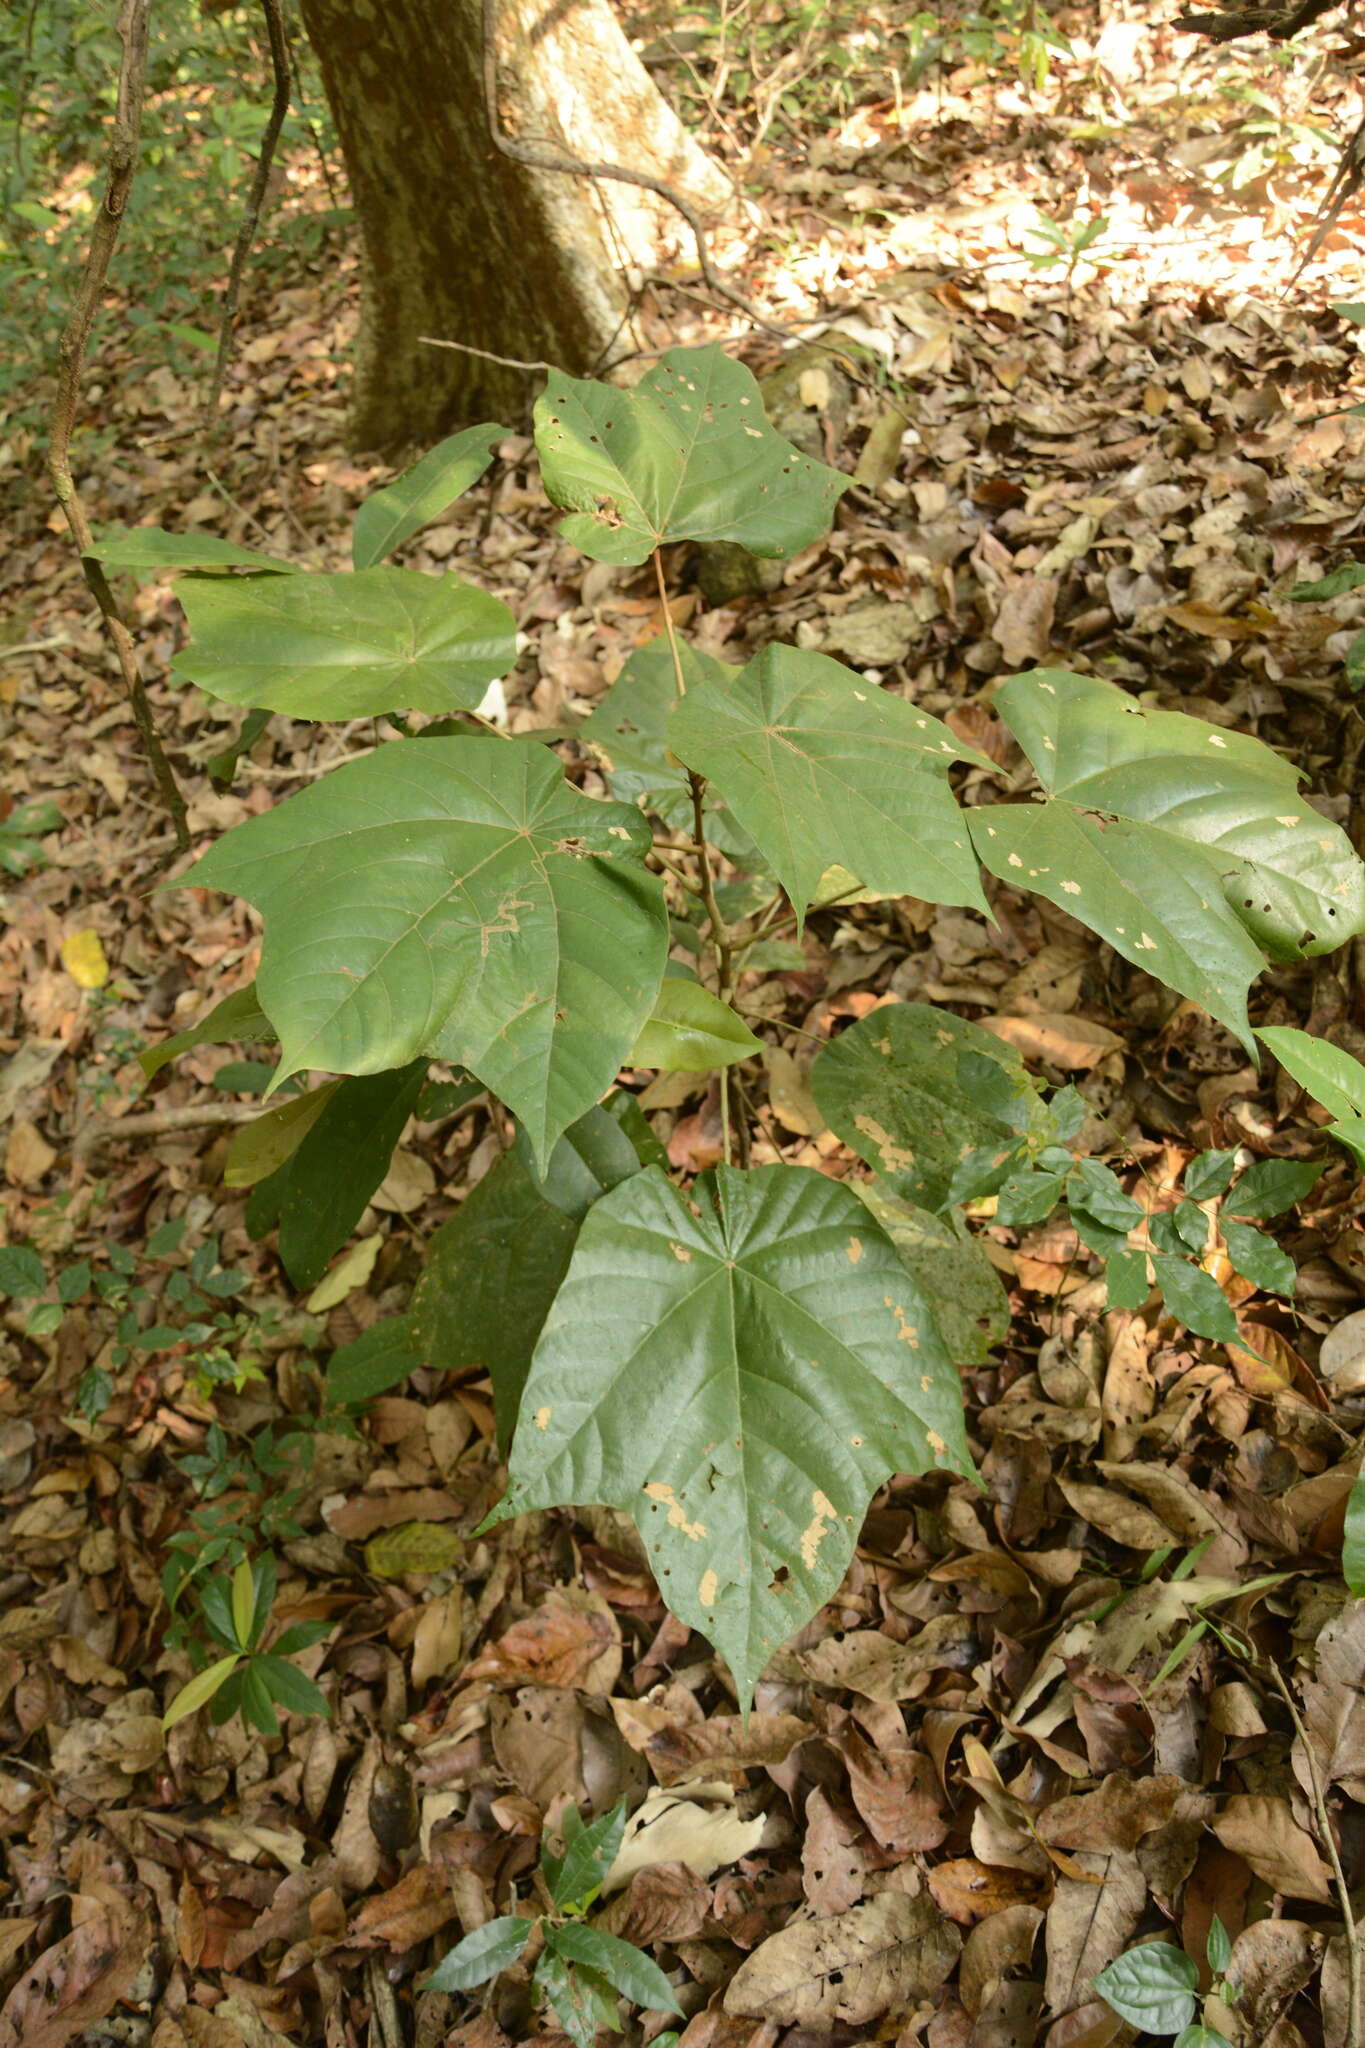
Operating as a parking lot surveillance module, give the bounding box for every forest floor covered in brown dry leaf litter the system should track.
[0,10,1365,2048]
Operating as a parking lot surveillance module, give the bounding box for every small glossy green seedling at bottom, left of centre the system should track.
[422,1800,681,2048]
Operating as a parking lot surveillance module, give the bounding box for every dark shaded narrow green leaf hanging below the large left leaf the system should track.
[248,1059,428,1288]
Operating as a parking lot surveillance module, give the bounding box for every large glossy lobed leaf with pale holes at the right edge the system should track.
[966,670,1365,1051]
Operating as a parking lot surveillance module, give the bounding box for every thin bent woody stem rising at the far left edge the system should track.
[47,0,190,852]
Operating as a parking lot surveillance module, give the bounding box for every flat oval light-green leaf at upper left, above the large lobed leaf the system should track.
[172,569,516,719]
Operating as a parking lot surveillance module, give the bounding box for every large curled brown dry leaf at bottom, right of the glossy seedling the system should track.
[724,1892,962,2030]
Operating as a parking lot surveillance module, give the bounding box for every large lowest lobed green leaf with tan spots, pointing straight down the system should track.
[497,1165,970,1710]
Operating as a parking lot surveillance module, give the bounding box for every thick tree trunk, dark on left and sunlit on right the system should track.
[294,0,729,453]
